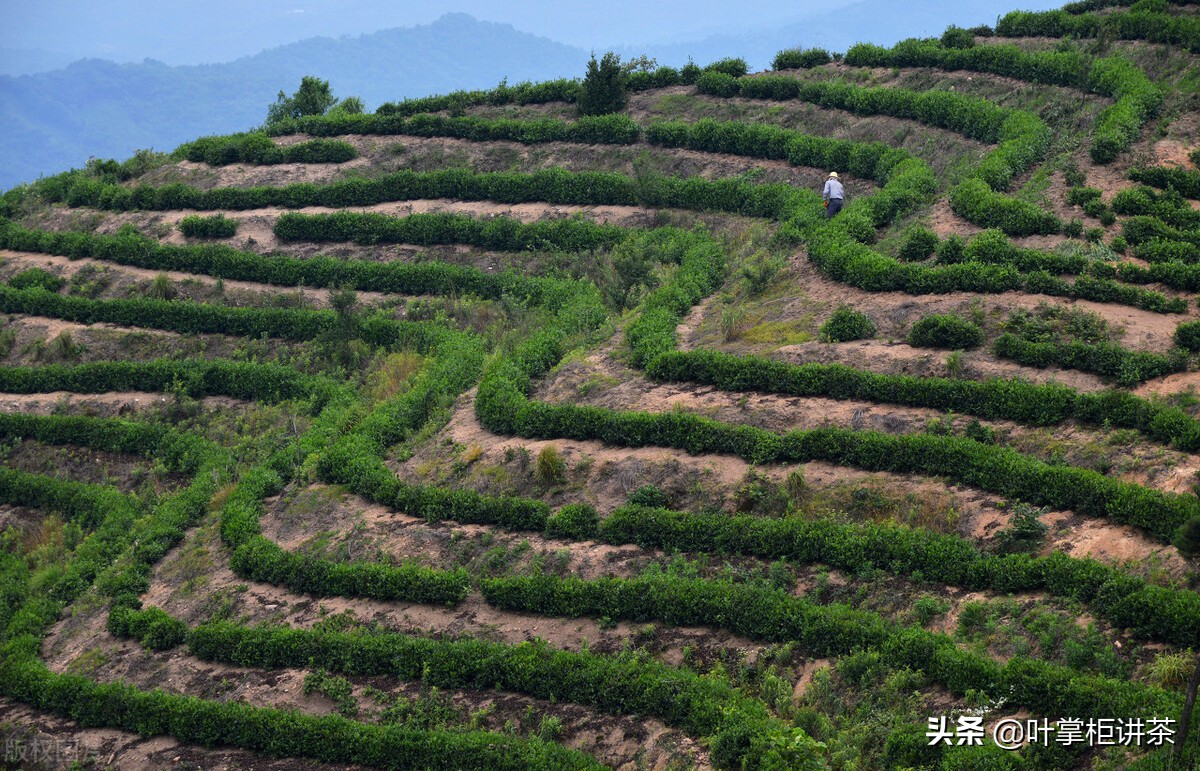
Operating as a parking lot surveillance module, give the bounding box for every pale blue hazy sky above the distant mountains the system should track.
[0,0,859,65]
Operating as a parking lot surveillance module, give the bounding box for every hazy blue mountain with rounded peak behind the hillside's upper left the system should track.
[0,14,587,190]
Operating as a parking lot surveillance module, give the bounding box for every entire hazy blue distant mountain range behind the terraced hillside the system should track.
[0,0,1070,190]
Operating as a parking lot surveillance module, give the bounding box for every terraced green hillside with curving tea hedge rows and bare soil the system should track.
[0,0,1200,771]
